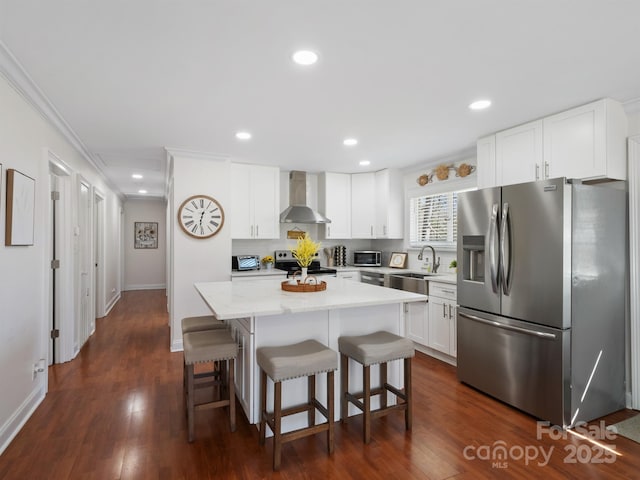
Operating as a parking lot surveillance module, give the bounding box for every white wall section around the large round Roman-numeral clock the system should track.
[169,150,231,351]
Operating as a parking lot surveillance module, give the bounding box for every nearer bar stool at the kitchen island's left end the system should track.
[182,330,238,442]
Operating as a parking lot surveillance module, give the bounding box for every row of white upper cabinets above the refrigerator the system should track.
[477,99,627,188]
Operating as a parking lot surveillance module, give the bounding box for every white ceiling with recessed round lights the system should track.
[0,0,640,196]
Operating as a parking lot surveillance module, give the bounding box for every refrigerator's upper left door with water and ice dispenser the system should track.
[457,187,500,314]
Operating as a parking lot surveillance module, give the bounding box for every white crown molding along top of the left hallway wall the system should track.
[0,40,125,200]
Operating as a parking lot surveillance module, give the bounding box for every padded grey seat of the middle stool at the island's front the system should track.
[256,340,338,382]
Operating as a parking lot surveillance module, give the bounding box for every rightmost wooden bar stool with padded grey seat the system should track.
[338,331,415,443]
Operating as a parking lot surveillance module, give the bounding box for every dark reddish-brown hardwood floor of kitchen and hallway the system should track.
[0,291,640,480]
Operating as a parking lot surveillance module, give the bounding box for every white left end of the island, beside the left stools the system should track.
[231,318,254,418]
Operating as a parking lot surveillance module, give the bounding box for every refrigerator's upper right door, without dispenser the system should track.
[500,178,571,328]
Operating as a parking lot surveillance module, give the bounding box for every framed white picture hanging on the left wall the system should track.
[4,168,36,246]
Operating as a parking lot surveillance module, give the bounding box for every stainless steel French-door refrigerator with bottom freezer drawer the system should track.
[457,178,627,427]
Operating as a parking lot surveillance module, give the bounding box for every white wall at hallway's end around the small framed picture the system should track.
[123,199,166,290]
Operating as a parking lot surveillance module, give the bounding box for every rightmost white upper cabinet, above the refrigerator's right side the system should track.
[543,99,627,180]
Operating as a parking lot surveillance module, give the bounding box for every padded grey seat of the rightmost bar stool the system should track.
[338,331,415,366]
